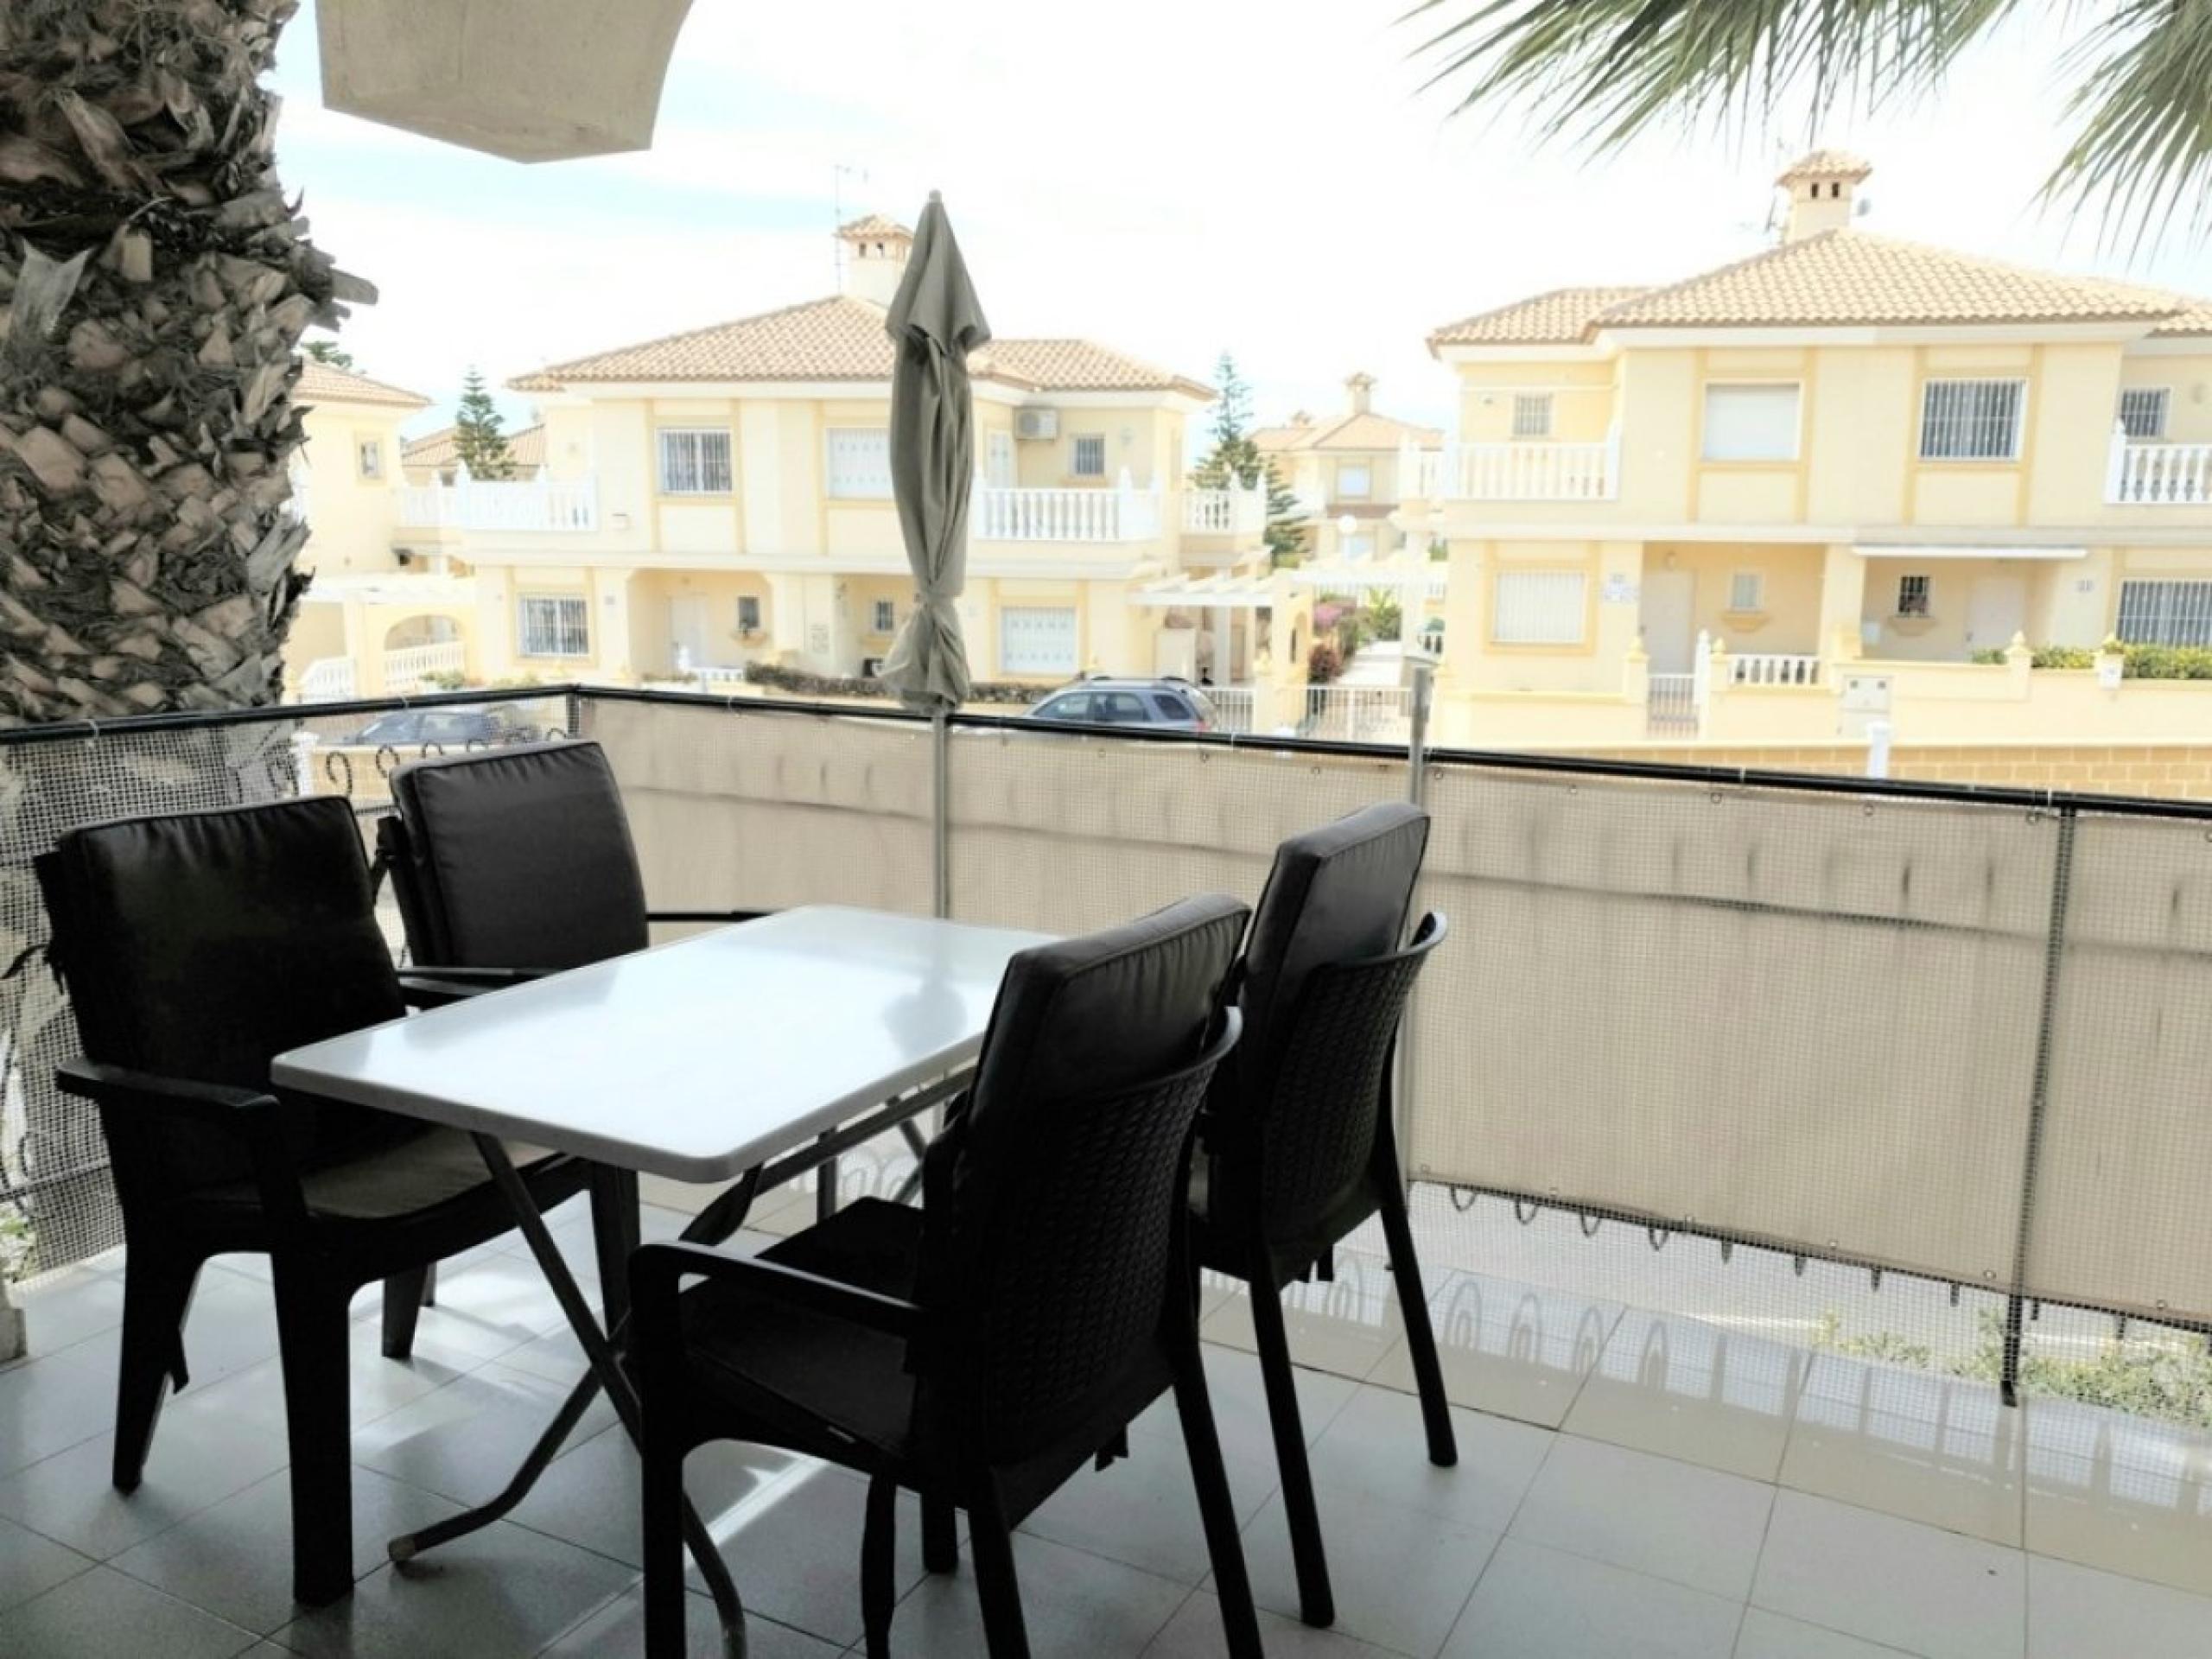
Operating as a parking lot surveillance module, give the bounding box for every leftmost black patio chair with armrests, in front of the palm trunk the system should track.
[38,797,606,1604]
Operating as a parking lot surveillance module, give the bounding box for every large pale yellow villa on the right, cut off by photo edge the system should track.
[1398,150,2212,747]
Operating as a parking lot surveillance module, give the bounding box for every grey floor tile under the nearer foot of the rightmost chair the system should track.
[1245,1486,1497,1659]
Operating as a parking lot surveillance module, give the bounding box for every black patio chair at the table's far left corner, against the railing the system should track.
[376,741,763,1351]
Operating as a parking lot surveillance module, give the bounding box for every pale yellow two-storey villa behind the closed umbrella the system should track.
[373,217,1303,686]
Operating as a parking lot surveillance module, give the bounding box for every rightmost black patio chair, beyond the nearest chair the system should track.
[1192,803,1460,1624]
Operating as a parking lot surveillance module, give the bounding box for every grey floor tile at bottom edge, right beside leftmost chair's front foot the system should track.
[276,1522,637,1659]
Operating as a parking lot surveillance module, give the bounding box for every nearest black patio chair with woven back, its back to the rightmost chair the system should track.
[632,898,1261,1659]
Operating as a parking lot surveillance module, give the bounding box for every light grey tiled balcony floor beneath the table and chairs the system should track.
[0,1208,2212,1659]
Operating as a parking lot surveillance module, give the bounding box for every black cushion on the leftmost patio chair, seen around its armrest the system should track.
[38,797,420,1192]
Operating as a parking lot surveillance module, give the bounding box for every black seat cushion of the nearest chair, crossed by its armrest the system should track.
[681,1199,923,1460]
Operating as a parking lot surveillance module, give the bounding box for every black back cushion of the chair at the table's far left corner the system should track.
[391,743,648,969]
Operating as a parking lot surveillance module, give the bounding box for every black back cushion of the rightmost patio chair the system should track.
[1224,801,1429,1090]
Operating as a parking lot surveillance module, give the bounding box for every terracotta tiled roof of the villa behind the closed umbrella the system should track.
[509,294,1214,398]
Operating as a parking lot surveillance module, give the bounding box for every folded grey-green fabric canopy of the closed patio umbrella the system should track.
[882,190,991,715]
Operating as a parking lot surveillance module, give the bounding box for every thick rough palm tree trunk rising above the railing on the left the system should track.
[0,0,374,726]
